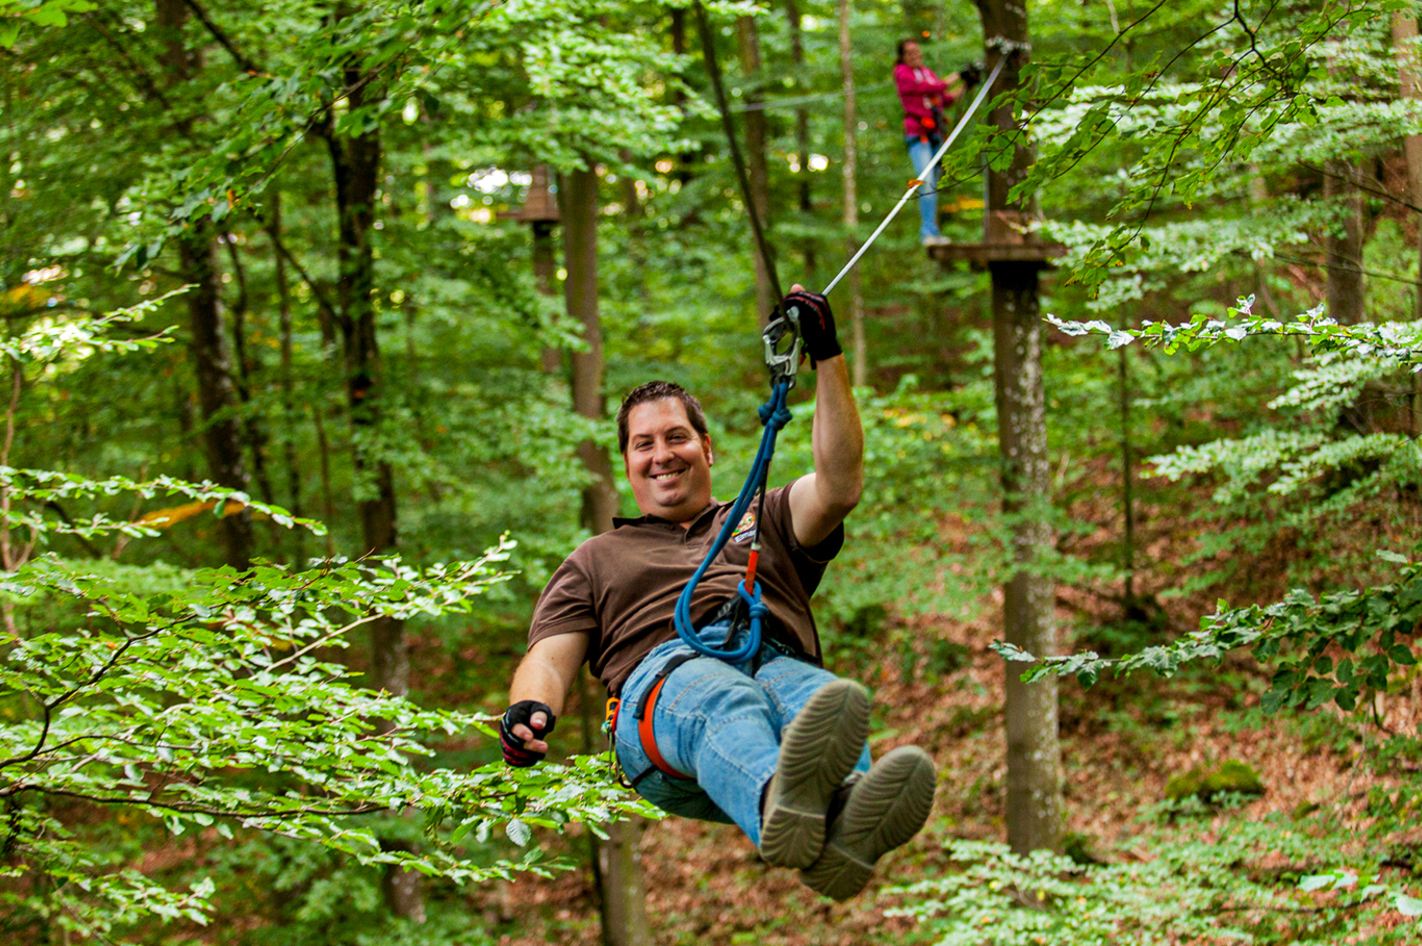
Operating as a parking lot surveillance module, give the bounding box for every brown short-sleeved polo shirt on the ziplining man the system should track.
[529,487,845,693]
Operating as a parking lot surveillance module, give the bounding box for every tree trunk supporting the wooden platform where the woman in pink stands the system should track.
[977,0,1062,854]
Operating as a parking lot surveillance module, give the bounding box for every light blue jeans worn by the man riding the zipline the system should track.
[617,623,869,846]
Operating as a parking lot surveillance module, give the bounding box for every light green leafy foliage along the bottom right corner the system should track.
[886,812,1422,946]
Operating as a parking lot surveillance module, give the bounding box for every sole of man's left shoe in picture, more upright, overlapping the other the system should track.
[761,680,869,868]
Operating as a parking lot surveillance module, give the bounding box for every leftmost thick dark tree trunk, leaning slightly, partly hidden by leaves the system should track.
[154,0,252,569]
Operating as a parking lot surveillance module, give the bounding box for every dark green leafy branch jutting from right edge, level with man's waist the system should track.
[991,553,1422,713]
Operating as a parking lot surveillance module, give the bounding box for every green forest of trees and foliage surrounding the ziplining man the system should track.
[8,0,1422,946]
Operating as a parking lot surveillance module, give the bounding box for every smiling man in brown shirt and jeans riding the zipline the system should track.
[499,286,936,900]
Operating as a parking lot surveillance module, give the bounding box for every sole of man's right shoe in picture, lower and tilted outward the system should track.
[801,745,937,900]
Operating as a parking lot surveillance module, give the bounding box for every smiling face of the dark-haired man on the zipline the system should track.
[623,397,715,524]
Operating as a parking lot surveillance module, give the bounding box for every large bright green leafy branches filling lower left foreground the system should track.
[0,539,644,936]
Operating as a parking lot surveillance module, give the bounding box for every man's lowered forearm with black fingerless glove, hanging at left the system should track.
[499,633,587,767]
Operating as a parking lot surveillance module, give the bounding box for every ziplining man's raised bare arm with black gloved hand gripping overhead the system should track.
[785,285,865,548]
